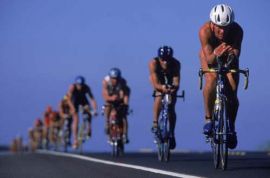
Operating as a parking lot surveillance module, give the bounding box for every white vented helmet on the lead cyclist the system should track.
[210,4,234,26]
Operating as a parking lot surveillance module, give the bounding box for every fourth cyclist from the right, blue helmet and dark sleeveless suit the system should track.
[68,76,97,149]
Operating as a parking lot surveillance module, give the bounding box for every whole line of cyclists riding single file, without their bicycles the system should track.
[11,4,243,154]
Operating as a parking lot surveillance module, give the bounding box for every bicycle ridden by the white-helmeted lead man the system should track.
[199,59,249,170]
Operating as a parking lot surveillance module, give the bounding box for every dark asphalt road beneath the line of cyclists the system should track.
[0,152,270,178]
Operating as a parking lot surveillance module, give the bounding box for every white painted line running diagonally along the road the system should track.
[37,150,202,178]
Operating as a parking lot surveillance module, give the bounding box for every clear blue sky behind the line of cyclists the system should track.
[0,0,270,151]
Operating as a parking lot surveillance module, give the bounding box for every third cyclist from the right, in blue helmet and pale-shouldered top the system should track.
[102,68,130,143]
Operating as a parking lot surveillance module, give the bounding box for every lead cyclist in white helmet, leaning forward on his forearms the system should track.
[199,4,243,149]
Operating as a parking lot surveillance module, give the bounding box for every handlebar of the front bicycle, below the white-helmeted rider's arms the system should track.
[199,68,249,90]
